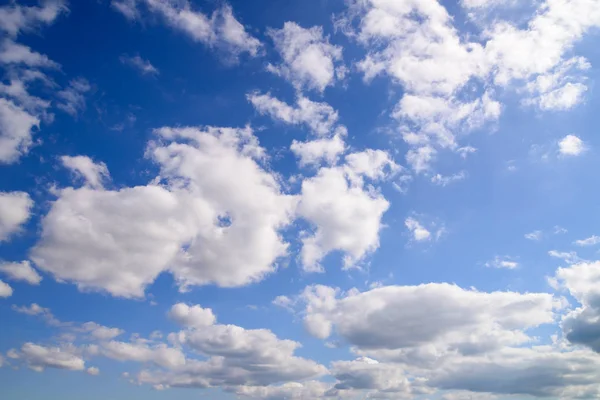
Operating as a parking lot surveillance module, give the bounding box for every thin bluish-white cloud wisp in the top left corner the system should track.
[0,0,68,36]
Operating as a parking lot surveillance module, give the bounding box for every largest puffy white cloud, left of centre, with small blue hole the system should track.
[31,128,296,297]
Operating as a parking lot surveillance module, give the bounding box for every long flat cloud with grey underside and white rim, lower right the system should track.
[302,283,559,364]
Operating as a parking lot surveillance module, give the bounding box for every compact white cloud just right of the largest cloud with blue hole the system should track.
[298,151,389,272]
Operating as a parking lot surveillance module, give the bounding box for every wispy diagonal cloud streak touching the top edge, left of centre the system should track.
[112,0,261,61]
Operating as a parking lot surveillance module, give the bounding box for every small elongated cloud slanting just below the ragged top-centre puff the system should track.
[246,92,338,136]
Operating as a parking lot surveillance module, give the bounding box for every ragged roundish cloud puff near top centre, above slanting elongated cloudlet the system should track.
[268,21,343,92]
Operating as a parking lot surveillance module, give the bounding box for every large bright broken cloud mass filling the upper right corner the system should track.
[338,0,600,173]
